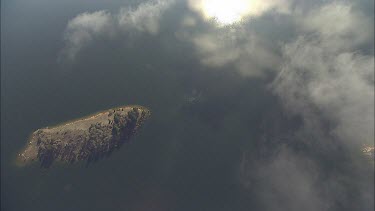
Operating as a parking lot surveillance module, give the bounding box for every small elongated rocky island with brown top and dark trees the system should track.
[17,106,151,168]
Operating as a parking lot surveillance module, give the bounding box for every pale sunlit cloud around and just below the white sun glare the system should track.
[176,0,298,77]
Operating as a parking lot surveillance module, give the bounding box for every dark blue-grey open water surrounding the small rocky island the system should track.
[1,1,267,211]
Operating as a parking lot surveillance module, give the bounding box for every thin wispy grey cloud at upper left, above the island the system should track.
[60,0,173,61]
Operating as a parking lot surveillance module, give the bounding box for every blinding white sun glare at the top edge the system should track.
[195,0,251,25]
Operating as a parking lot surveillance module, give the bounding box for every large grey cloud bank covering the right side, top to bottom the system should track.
[229,1,374,210]
